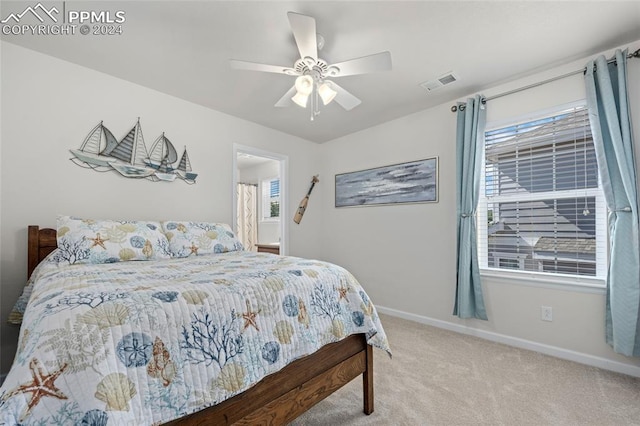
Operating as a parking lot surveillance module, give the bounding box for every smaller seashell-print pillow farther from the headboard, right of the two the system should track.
[162,221,244,257]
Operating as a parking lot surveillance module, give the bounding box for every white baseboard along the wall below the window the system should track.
[376,305,640,377]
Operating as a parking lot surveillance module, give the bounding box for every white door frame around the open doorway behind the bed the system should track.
[231,143,289,255]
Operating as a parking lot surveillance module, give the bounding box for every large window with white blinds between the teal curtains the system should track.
[478,105,607,278]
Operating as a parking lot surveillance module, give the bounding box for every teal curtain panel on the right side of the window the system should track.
[585,50,640,356]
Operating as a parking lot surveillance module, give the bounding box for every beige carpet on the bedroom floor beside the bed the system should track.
[292,315,640,426]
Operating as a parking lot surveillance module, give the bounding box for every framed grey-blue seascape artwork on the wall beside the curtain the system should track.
[335,157,438,207]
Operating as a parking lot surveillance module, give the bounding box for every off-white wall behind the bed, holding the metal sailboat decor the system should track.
[0,42,321,372]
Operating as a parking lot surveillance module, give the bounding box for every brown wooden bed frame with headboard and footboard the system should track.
[27,226,373,425]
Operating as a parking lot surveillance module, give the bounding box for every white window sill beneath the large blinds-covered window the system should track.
[480,268,607,294]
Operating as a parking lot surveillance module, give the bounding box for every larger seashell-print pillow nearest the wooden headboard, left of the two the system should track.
[56,216,171,264]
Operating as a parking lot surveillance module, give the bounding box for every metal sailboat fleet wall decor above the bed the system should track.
[69,118,198,184]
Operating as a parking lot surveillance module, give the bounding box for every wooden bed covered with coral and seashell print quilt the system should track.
[0,218,391,425]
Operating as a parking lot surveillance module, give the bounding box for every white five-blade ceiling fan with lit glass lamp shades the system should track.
[231,12,391,120]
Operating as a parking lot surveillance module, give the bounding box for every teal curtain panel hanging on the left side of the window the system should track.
[453,95,487,320]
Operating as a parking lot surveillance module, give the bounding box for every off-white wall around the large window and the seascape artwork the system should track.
[318,42,640,374]
